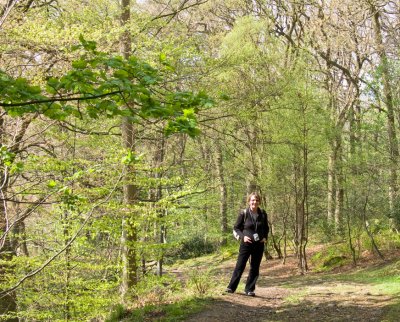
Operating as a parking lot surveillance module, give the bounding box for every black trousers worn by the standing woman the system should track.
[228,242,264,292]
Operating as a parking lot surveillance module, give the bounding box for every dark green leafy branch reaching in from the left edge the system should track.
[0,36,212,136]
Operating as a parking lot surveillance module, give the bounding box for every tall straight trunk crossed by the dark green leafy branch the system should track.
[121,0,138,302]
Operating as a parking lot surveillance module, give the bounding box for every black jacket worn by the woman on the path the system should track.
[233,208,269,241]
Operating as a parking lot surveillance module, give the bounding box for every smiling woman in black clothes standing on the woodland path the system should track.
[225,192,269,296]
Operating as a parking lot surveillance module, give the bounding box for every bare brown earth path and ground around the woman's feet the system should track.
[185,249,400,322]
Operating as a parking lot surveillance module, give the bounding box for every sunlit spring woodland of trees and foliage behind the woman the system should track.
[0,0,400,321]
